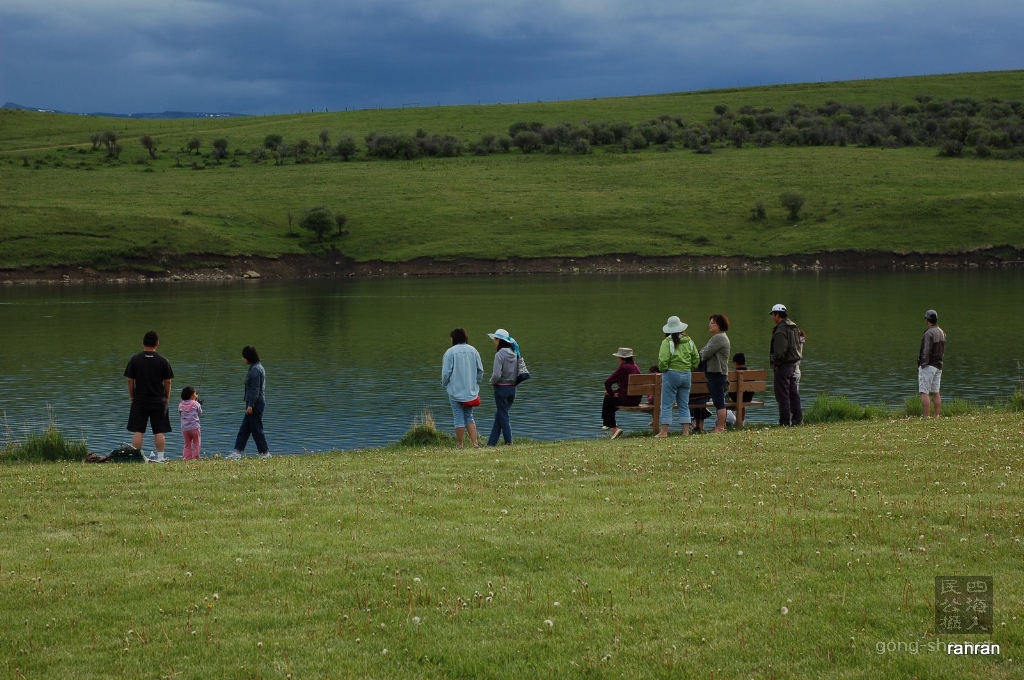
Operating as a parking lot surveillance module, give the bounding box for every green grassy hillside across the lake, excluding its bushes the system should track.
[0,72,1024,268]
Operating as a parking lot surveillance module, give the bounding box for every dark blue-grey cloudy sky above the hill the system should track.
[0,0,1024,114]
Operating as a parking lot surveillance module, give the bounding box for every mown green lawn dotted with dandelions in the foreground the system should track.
[0,415,1024,678]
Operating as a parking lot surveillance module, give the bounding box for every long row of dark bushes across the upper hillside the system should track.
[81,95,1024,165]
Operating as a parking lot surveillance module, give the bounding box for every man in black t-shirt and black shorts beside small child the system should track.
[125,331,174,463]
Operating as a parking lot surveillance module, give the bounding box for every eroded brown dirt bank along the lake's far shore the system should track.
[0,246,1024,286]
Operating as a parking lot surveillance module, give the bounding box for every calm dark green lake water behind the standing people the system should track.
[0,270,1024,457]
